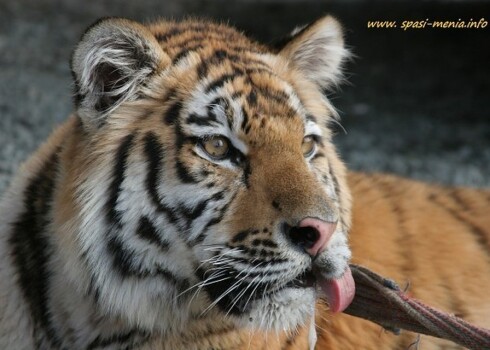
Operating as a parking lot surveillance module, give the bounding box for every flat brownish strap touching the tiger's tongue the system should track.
[344,265,490,350]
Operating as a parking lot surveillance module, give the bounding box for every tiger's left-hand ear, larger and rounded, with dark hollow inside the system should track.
[71,18,170,127]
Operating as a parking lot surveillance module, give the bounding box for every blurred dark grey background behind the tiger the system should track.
[0,0,490,193]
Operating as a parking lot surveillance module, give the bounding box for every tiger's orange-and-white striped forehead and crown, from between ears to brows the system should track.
[150,21,321,150]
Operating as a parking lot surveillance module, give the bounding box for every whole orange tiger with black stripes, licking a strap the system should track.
[0,15,490,350]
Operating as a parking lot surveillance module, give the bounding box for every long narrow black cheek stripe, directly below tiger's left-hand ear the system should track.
[106,134,135,224]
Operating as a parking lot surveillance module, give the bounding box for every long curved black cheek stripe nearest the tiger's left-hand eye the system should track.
[144,132,177,224]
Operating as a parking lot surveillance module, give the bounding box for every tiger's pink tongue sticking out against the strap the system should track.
[317,268,356,312]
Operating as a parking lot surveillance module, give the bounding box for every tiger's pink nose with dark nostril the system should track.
[286,218,337,257]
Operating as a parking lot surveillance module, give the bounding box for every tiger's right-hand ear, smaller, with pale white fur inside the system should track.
[277,16,349,89]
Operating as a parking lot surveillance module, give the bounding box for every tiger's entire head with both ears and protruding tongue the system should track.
[67,17,352,332]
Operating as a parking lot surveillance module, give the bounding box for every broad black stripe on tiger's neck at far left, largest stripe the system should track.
[9,153,61,349]
